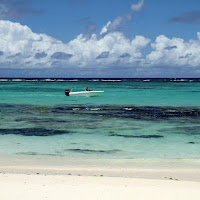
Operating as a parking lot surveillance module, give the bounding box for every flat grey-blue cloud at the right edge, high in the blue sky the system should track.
[169,11,200,24]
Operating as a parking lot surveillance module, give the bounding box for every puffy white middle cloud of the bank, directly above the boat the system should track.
[68,32,150,67]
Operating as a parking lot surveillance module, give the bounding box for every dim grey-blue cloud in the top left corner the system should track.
[0,0,42,19]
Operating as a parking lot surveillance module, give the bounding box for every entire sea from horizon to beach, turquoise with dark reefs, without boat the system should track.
[0,79,200,159]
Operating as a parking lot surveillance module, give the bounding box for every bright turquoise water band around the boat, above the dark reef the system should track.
[0,79,200,106]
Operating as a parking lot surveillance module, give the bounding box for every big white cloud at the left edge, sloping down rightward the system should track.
[0,20,70,68]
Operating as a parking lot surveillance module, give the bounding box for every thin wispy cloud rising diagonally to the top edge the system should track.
[100,0,144,36]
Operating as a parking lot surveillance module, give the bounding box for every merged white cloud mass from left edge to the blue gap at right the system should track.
[0,20,150,68]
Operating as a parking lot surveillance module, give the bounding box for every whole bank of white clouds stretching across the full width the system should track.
[0,18,200,77]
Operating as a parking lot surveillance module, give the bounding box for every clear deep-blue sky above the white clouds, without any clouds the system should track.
[19,0,200,42]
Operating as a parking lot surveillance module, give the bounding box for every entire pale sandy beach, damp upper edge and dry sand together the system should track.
[0,157,200,200]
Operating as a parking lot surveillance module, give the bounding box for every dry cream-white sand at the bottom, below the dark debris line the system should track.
[0,173,200,200]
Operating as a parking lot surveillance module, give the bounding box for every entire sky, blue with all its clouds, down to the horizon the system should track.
[0,0,200,78]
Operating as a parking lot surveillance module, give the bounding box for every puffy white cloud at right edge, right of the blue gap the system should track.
[146,33,200,67]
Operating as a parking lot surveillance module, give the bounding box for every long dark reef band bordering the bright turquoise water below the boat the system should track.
[0,104,200,120]
